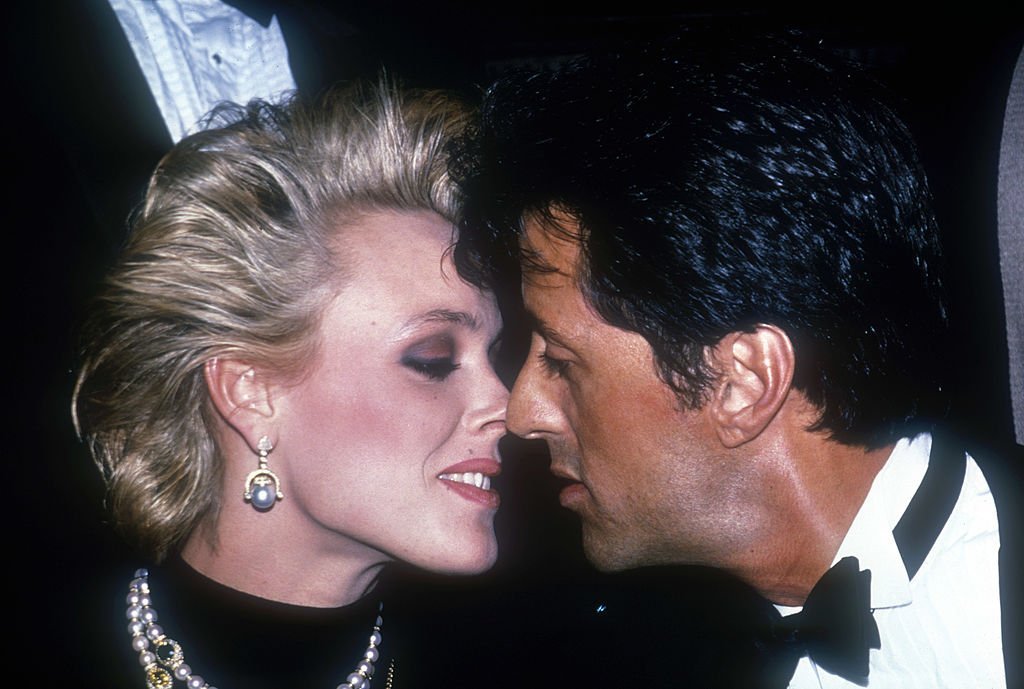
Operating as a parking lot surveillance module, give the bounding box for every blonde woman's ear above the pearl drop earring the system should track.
[203,358,273,451]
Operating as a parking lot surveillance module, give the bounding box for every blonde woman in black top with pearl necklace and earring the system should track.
[74,77,507,689]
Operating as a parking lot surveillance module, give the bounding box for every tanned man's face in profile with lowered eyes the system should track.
[508,214,730,570]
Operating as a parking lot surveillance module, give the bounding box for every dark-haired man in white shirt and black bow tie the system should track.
[457,29,1018,688]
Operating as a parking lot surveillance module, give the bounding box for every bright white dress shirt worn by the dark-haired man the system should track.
[777,434,1006,689]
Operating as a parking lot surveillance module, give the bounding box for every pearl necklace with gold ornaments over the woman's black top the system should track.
[125,569,393,689]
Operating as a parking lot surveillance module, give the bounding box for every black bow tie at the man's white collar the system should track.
[774,557,882,685]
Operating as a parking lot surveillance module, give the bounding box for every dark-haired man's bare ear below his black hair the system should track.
[709,325,796,447]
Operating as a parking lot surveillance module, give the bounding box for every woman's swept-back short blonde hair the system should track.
[72,80,469,559]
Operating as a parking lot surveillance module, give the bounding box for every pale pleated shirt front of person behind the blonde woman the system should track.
[110,0,295,141]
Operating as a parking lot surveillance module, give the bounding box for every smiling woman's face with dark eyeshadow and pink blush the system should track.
[270,212,508,573]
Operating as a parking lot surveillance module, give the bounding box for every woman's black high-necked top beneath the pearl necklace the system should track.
[77,556,409,689]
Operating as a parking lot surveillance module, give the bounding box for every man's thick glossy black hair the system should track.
[454,26,946,446]
